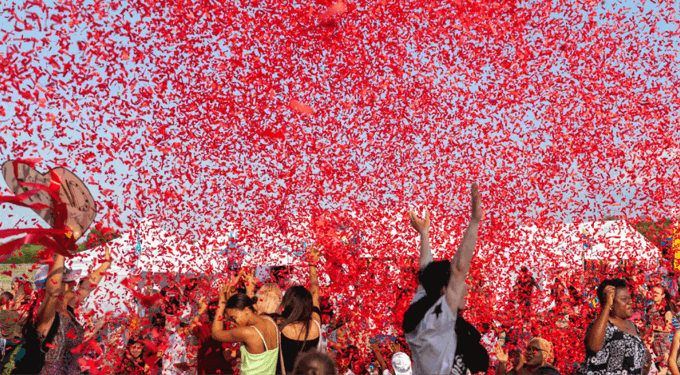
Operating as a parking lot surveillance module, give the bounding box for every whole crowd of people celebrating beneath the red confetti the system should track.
[0,185,680,375]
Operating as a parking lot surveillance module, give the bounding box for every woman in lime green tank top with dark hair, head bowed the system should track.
[212,284,279,375]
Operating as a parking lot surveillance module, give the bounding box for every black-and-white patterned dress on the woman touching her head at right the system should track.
[578,322,647,375]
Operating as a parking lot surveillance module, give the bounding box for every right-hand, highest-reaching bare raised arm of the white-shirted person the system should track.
[445,183,484,314]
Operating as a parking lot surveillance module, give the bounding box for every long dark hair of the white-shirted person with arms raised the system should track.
[402,260,451,333]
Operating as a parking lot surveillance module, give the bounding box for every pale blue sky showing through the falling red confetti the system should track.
[0,1,680,254]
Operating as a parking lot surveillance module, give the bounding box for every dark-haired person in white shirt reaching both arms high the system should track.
[402,183,483,375]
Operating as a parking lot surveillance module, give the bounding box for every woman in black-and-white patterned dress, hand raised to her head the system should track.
[579,279,651,375]
